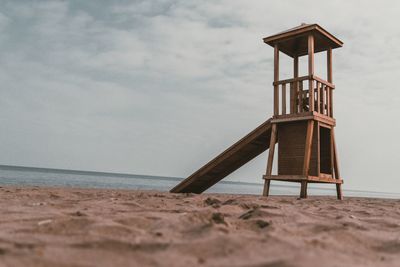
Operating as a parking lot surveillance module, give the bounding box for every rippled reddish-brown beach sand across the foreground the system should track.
[0,187,400,267]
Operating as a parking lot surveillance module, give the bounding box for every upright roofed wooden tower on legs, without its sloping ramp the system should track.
[263,24,343,199]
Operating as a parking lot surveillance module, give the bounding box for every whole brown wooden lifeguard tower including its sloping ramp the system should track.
[171,24,343,199]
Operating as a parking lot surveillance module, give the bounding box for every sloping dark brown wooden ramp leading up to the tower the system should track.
[170,119,271,193]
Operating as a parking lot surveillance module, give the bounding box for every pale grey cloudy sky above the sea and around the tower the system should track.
[0,0,400,192]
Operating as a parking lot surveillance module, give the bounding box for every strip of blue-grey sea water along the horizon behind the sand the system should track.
[0,165,400,198]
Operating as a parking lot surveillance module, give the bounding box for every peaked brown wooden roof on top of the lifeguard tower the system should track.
[263,23,343,57]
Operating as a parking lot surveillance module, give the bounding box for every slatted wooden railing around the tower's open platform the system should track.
[273,75,335,117]
